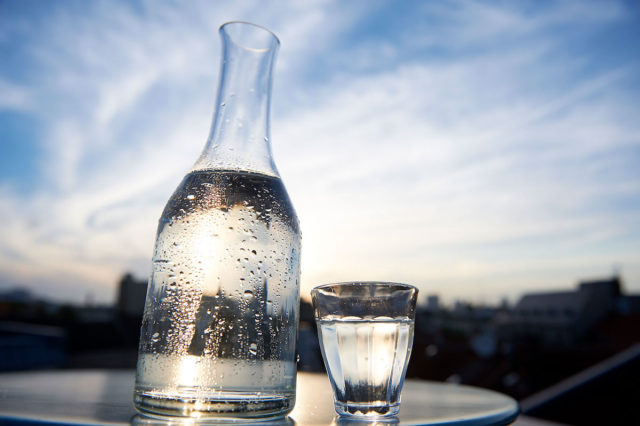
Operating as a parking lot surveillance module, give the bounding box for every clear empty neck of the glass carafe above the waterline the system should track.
[192,22,279,176]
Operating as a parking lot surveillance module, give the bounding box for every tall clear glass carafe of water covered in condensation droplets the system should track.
[134,22,300,419]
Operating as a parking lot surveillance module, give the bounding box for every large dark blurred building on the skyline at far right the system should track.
[507,277,621,344]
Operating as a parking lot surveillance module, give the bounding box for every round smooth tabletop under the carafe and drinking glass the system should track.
[0,370,519,425]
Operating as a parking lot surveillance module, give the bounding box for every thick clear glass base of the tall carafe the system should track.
[134,389,295,422]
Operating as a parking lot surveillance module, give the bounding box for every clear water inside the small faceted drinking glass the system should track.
[318,316,413,415]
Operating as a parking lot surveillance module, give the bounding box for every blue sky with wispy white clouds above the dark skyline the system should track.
[0,0,640,302]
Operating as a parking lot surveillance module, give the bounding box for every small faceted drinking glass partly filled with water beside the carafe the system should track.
[311,282,418,417]
